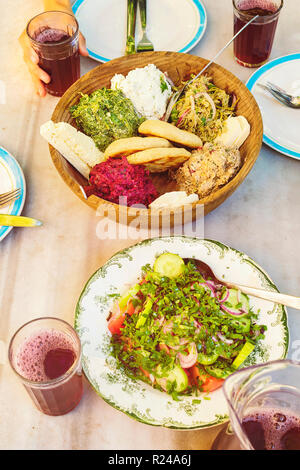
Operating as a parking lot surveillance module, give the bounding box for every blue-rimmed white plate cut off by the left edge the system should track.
[0,147,26,241]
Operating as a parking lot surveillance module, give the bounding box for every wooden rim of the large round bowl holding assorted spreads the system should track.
[49,51,263,221]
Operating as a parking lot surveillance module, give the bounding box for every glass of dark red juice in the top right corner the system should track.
[233,0,283,67]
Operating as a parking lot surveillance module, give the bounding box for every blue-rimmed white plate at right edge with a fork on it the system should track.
[247,54,300,159]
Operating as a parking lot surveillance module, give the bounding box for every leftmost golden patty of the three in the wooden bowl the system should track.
[104,137,172,159]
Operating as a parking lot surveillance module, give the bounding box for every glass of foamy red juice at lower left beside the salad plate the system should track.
[8,317,83,416]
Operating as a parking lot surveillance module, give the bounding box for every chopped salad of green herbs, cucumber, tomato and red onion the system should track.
[108,253,266,399]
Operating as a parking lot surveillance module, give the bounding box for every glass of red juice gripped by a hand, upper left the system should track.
[27,11,80,96]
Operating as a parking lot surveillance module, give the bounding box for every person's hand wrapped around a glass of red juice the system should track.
[19,31,89,97]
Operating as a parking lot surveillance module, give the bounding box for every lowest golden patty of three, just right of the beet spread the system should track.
[127,147,191,173]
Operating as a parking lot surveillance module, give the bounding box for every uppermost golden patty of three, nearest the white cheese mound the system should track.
[139,119,202,148]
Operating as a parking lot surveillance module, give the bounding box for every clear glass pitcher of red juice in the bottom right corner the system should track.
[212,360,300,450]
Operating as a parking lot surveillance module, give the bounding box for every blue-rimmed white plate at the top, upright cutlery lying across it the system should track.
[73,0,207,62]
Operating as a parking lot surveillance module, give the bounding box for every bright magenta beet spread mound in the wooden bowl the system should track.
[84,157,158,207]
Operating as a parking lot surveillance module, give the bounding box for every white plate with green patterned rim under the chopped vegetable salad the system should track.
[75,236,289,430]
